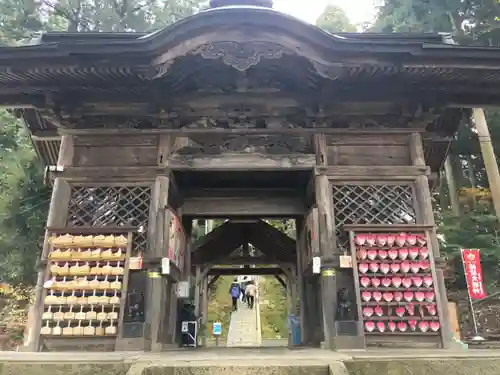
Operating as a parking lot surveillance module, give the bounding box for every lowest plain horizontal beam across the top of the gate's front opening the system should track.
[182,197,306,218]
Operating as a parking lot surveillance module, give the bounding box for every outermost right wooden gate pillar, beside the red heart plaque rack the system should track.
[410,133,453,348]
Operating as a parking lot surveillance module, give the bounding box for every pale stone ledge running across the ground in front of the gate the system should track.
[0,351,500,375]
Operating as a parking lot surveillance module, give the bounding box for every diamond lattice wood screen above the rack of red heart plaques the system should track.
[333,185,416,250]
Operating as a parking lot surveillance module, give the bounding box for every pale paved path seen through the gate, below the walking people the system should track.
[227,301,261,347]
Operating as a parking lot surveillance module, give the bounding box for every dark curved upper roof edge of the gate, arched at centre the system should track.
[0,7,500,76]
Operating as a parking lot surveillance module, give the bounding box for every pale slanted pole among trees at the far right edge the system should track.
[472,108,500,218]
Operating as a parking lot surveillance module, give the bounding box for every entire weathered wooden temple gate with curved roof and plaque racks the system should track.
[0,0,500,351]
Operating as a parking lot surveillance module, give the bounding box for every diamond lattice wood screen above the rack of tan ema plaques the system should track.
[67,186,151,253]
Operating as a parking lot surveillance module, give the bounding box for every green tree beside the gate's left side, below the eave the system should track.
[0,112,50,283]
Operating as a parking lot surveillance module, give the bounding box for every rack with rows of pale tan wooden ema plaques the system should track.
[40,234,130,350]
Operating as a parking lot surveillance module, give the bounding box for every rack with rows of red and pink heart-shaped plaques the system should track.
[351,232,441,346]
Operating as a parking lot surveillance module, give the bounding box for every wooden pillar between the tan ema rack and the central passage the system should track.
[146,176,170,351]
